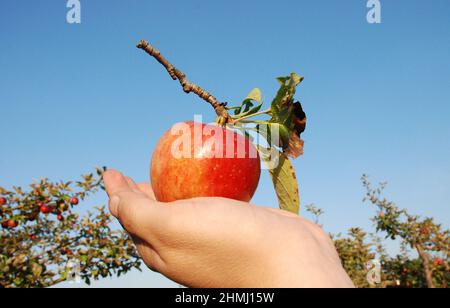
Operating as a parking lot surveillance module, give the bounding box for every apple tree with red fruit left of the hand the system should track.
[0,169,141,288]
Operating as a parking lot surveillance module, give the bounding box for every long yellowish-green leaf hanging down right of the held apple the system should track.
[258,147,300,214]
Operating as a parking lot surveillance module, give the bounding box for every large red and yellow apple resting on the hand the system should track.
[150,122,261,202]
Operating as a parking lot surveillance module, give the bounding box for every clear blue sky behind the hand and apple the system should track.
[0,0,450,286]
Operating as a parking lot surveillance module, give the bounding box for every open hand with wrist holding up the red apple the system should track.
[104,170,354,288]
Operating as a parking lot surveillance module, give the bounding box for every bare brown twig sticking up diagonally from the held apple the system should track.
[136,40,233,125]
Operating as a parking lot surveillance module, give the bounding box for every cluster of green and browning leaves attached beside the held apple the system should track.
[227,73,306,214]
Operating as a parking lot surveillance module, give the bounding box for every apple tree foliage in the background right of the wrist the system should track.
[314,176,450,288]
